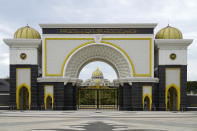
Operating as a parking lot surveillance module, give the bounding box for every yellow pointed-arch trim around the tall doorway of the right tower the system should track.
[165,83,181,111]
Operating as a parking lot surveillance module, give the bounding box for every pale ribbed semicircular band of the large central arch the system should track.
[63,43,133,78]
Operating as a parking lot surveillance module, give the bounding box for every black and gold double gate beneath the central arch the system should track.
[78,87,118,109]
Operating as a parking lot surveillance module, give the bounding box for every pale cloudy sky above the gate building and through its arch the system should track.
[0,0,197,80]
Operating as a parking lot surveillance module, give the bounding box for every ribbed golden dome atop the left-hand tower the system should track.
[14,25,40,39]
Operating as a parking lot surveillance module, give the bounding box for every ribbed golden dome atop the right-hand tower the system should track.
[155,25,183,39]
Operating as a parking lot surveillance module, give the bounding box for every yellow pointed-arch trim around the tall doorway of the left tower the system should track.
[16,83,31,110]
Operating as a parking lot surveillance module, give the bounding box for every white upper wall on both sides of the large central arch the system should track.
[42,34,154,77]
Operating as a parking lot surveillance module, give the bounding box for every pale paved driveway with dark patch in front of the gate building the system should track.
[0,110,197,131]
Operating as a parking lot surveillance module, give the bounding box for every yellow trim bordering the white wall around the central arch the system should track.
[44,38,152,77]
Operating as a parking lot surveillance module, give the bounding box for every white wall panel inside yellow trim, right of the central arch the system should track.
[106,40,152,74]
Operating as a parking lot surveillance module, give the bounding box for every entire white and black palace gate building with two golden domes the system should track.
[4,23,192,110]
